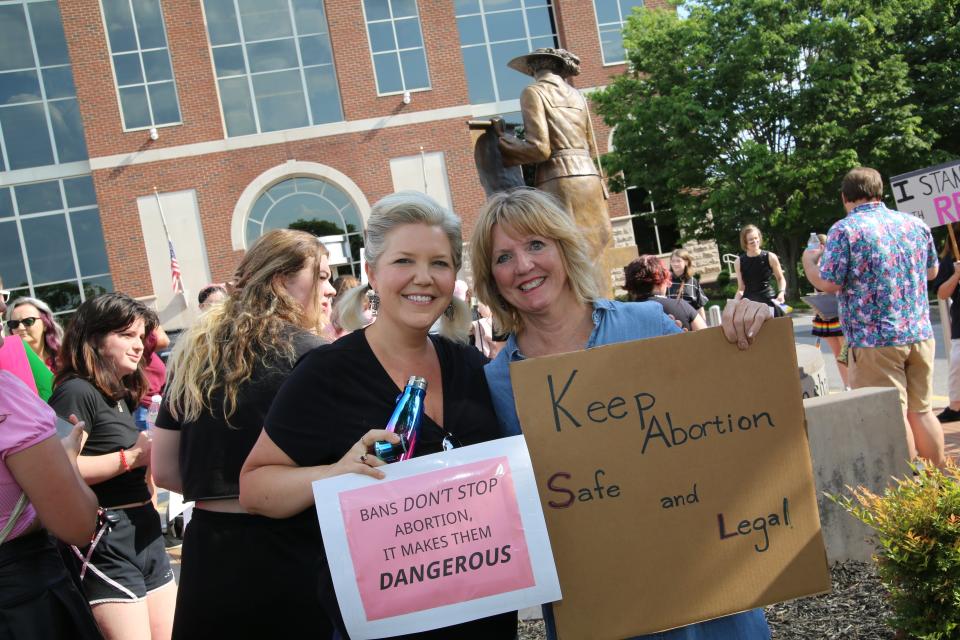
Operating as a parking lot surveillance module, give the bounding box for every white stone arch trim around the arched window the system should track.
[230,160,370,251]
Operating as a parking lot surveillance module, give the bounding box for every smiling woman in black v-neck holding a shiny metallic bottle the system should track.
[240,192,517,640]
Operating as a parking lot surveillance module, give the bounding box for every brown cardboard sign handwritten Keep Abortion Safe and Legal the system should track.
[510,319,830,640]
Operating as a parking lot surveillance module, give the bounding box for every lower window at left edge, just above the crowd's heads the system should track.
[0,176,113,314]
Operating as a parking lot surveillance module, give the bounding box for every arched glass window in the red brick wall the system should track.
[246,177,363,276]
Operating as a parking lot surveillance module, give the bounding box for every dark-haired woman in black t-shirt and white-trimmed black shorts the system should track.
[50,293,177,640]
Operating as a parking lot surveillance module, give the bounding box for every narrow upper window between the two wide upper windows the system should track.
[363,0,430,95]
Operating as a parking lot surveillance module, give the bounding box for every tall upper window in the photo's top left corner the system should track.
[0,2,87,171]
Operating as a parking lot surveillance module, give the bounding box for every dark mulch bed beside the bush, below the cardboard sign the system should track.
[520,562,895,640]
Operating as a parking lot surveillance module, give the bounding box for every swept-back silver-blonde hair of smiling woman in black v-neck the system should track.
[337,191,470,343]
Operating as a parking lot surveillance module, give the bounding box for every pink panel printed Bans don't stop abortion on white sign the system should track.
[340,457,534,620]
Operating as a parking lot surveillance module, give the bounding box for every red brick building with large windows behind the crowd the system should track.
[0,0,712,328]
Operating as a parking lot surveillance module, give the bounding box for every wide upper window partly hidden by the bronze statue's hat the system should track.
[454,0,558,104]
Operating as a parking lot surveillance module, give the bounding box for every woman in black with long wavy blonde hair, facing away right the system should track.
[153,229,334,638]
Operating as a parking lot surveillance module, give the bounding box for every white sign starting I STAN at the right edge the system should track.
[890,160,960,228]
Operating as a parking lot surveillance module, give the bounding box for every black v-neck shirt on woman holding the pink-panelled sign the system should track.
[264,331,517,640]
